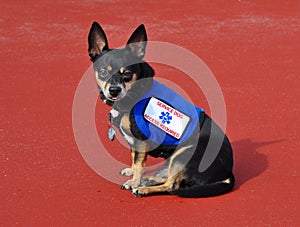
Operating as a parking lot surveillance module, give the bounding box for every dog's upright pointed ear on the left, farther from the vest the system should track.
[88,22,108,61]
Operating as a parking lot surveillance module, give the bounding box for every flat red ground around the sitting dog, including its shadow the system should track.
[0,0,300,226]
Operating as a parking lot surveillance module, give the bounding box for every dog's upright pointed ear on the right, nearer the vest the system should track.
[127,24,147,59]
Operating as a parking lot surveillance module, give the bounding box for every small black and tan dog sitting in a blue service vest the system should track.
[88,22,235,198]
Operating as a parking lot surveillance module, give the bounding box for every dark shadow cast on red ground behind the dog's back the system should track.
[232,139,283,189]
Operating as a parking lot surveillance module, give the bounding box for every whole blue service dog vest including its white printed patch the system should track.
[130,80,204,146]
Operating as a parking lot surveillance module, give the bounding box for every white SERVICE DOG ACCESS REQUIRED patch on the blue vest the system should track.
[144,97,190,139]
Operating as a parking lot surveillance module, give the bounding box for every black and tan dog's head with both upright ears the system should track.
[88,22,154,103]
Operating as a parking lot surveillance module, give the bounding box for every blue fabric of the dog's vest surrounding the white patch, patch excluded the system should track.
[133,80,205,145]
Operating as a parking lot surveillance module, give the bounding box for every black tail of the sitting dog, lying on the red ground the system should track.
[172,174,235,198]
